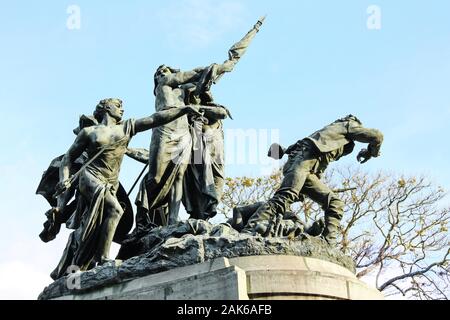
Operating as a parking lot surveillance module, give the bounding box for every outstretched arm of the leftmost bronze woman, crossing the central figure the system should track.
[135,106,201,133]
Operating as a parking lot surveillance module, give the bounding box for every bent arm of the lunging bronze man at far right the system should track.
[348,121,383,163]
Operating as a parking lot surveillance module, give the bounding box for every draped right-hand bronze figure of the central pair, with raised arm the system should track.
[183,17,265,220]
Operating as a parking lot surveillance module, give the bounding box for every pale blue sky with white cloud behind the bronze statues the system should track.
[0,0,450,299]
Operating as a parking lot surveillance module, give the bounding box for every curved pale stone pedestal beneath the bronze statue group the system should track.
[52,255,383,300]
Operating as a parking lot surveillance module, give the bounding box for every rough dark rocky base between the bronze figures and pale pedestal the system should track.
[39,220,372,300]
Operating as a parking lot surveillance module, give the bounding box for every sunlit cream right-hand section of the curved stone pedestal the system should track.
[230,256,384,300]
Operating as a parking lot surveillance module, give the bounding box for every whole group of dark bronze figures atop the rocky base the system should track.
[37,19,383,279]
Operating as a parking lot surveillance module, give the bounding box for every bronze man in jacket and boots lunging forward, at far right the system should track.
[243,115,383,245]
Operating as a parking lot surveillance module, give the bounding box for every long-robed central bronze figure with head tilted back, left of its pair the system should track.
[136,64,232,229]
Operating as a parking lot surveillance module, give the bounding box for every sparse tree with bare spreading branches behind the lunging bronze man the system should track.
[220,167,450,300]
